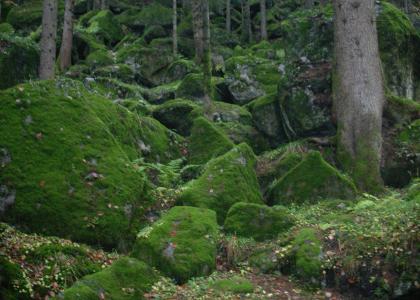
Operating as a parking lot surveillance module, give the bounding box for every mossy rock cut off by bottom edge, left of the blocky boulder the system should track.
[63,257,159,300]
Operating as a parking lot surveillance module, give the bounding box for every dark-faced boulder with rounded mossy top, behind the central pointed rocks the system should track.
[153,99,201,136]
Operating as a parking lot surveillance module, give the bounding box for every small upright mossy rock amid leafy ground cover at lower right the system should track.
[293,228,322,282]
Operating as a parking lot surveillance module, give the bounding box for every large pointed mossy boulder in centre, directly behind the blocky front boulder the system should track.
[177,144,262,224]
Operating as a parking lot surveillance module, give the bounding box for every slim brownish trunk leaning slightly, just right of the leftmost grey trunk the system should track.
[60,0,75,71]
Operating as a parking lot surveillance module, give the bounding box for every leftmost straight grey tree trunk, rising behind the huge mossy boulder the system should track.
[39,0,58,79]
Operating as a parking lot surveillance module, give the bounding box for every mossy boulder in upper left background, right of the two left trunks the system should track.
[86,10,123,44]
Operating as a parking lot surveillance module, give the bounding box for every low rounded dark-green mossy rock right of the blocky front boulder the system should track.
[224,202,294,241]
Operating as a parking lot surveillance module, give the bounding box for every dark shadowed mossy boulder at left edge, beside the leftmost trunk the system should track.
[0,33,39,89]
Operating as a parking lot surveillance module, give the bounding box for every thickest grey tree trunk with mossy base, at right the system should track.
[334,0,385,192]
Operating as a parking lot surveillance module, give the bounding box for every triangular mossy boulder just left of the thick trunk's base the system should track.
[269,151,356,204]
